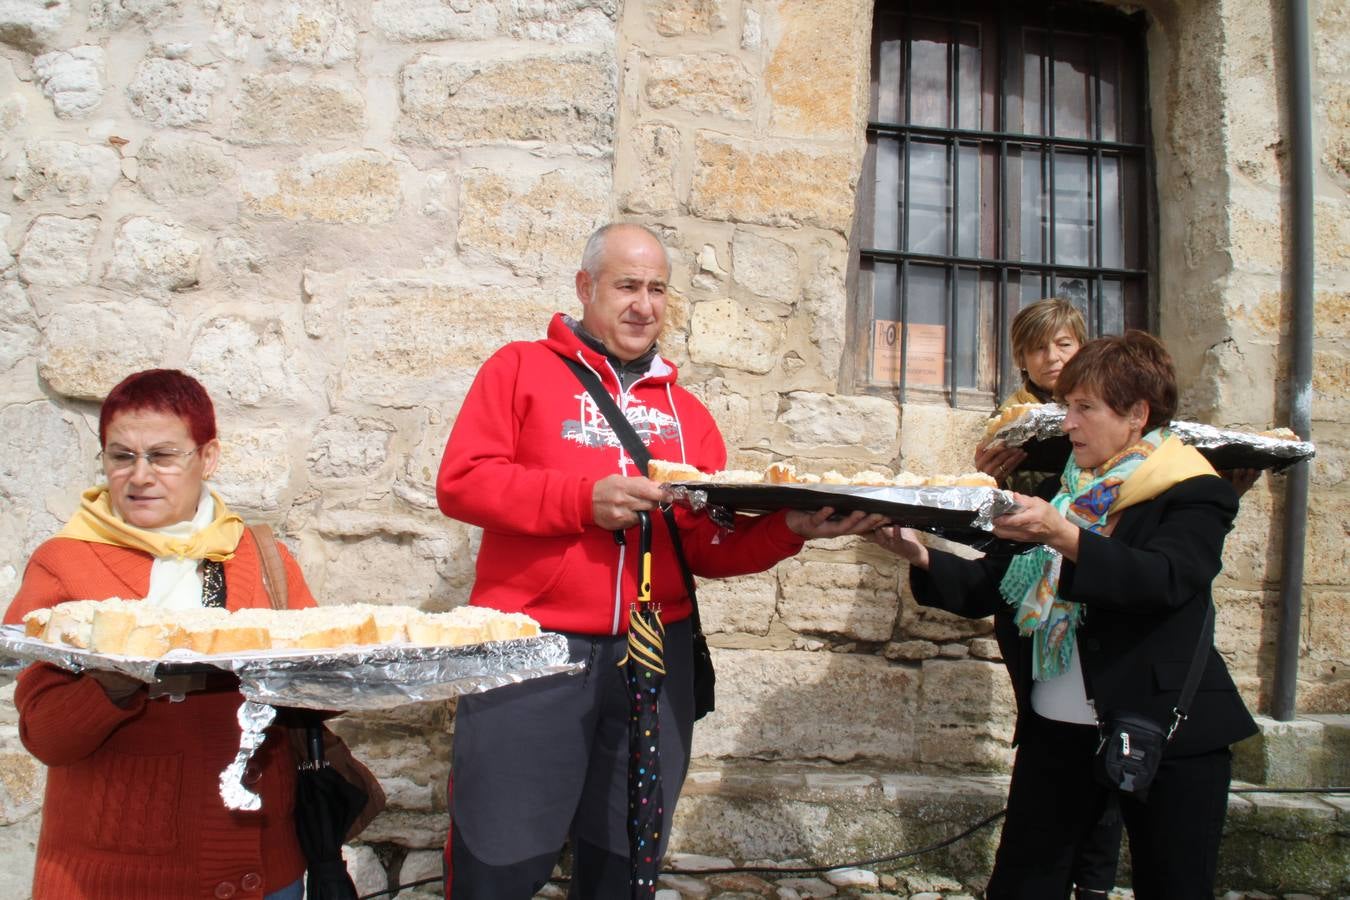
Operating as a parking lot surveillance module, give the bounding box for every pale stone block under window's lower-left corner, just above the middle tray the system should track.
[774,391,900,464]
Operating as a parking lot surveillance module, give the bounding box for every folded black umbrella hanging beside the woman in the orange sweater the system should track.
[296,722,367,900]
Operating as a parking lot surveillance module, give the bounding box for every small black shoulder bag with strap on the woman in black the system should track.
[1092,603,1214,800]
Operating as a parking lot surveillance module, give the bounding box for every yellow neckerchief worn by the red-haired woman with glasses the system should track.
[57,486,244,563]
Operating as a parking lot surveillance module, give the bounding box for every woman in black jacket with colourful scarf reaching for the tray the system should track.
[876,332,1257,900]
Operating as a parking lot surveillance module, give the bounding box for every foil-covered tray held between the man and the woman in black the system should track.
[667,482,1018,548]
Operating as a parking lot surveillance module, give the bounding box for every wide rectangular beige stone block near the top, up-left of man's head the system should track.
[397,51,618,150]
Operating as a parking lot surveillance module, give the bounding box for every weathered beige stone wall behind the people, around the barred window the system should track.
[0,0,1350,896]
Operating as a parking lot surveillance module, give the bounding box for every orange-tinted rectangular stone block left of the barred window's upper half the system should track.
[689,131,857,235]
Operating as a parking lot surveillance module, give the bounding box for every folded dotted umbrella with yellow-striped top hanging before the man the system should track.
[625,511,666,900]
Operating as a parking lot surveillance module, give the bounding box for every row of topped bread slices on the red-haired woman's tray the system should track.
[23,598,539,657]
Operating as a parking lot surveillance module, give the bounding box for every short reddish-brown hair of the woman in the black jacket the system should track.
[1054,331,1177,433]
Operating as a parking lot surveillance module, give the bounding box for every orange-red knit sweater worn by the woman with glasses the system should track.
[4,533,315,900]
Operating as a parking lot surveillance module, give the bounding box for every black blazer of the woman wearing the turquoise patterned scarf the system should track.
[910,475,1257,756]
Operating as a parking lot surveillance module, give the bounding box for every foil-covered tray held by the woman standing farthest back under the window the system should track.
[990,403,1316,472]
